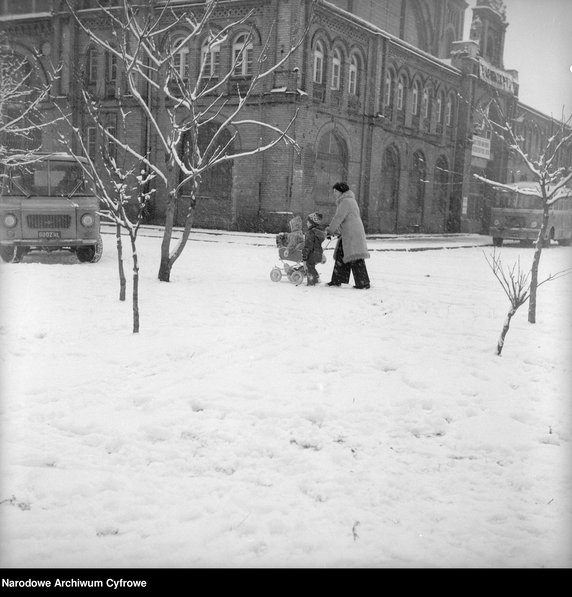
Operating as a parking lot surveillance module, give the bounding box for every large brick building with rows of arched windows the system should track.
[0,0,570,233]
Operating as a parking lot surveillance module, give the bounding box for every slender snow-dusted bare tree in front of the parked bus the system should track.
[474,99,572,323]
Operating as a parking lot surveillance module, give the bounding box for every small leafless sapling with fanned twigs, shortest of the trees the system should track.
[485,252,572,356]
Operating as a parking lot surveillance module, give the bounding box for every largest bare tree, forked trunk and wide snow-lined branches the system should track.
[66,0,307,282]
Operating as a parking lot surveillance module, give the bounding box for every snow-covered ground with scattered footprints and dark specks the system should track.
[0,231,572,568]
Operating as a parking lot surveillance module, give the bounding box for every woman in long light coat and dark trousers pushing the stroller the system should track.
[326,182,370,289]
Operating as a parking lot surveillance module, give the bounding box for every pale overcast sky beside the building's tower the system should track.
[465,0,572,119]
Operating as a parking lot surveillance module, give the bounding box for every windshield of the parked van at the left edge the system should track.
[3,160,90,198]
